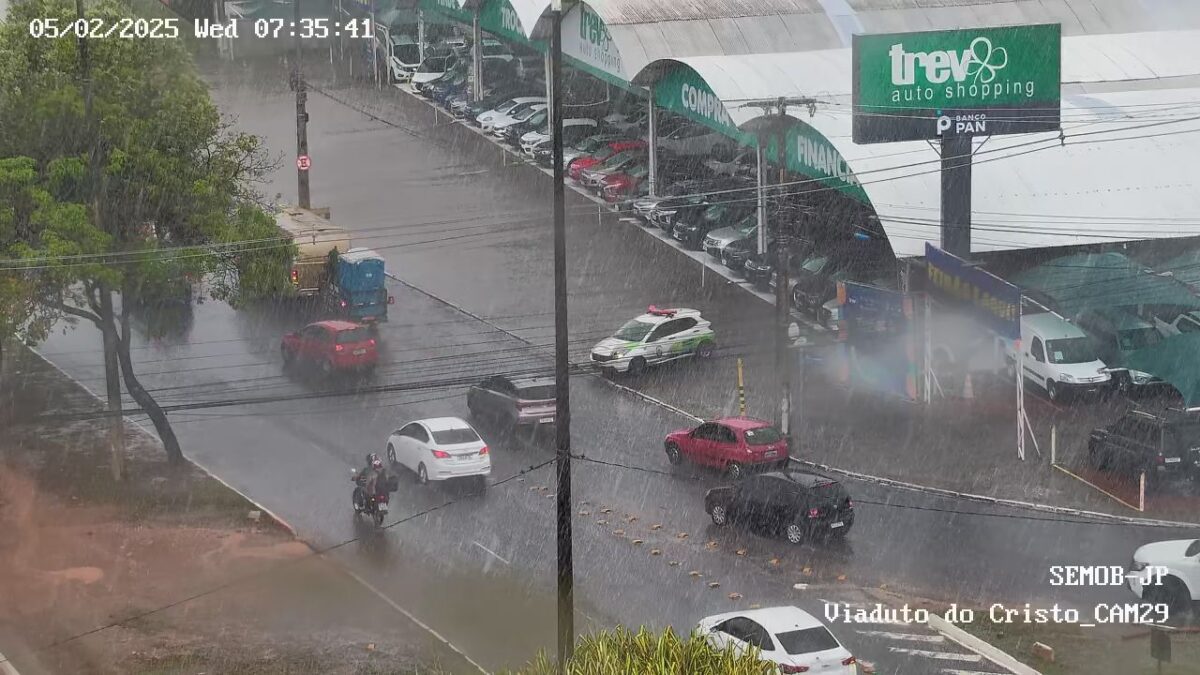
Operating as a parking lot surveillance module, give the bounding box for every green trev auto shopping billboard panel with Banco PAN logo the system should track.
[853,24,1062,143]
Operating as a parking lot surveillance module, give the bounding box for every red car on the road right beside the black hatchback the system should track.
[664,417,790,479]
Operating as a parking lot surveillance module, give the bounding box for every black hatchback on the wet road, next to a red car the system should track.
[704,471,854,544]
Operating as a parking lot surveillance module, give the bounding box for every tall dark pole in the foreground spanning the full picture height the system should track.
[550,0,575,674]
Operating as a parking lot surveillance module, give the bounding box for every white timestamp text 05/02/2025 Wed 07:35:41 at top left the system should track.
[29,17,374,40]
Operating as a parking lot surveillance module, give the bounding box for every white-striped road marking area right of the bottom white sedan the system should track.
[821,598,1009,675]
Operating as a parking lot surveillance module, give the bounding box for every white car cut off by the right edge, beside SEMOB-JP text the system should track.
[1127,539,1200,614]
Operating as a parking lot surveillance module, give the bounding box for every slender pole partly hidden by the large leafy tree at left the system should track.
[76,0,125,480]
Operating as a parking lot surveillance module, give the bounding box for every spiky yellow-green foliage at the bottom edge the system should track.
[499,627,778,675]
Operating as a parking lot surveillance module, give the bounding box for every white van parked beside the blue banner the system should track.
[1006,312,1112,401]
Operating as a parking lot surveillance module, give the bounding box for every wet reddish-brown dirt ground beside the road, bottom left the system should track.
[0,352,468,675]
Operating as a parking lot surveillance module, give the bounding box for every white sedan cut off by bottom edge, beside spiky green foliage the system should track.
[696,607,858,675]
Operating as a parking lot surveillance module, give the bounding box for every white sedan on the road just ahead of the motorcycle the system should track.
[388,417,492,488]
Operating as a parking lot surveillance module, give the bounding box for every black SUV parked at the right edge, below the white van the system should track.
[1087,411,1200,485]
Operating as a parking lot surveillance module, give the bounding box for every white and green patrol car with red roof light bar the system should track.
[592,305,716,375]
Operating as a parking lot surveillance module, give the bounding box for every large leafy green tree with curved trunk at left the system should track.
[0,0,292,462]
